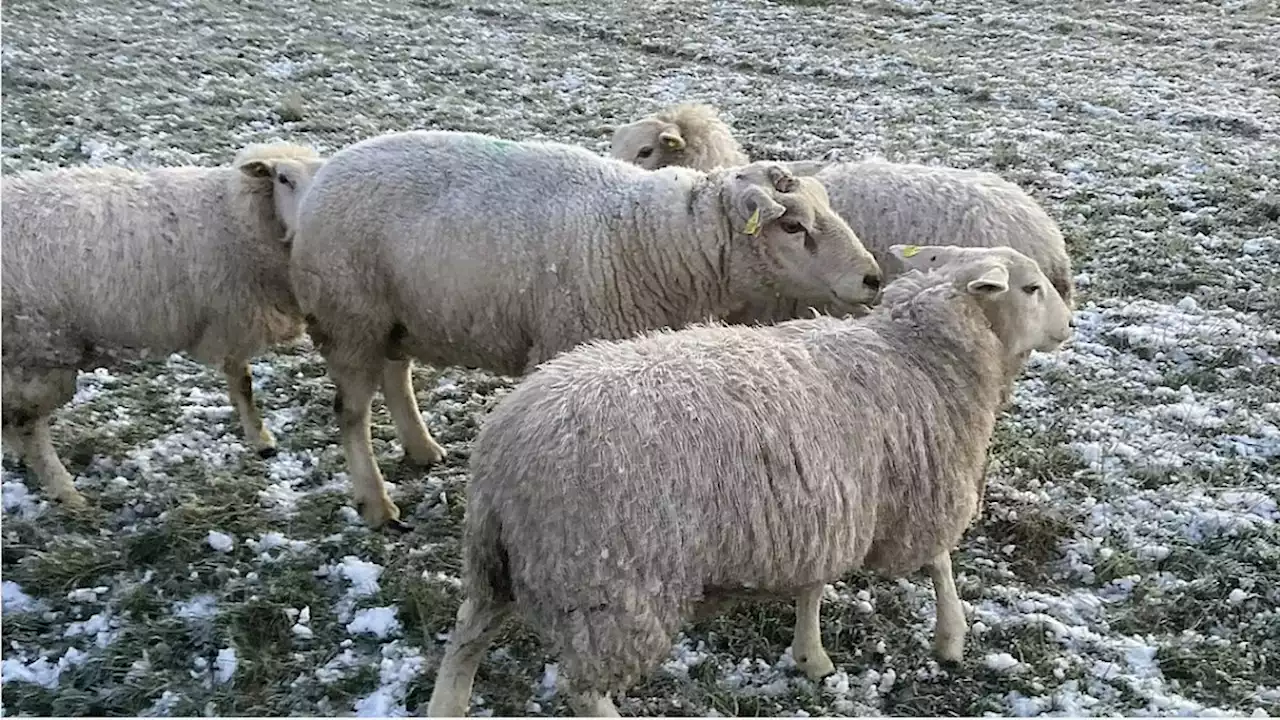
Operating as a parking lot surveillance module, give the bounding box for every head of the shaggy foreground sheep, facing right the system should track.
[890,245,1075,357]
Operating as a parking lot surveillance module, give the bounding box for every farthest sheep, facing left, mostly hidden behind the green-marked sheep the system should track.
[609,104,1074,315]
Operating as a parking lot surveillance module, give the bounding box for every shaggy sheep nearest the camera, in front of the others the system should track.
[428,246,1073,716]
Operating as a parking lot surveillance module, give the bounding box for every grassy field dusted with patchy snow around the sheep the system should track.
[3,0,1280,716]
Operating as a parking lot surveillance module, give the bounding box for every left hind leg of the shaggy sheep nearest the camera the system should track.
[426,598,507,717]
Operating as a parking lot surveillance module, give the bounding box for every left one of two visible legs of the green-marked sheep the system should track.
[329,364,408,530]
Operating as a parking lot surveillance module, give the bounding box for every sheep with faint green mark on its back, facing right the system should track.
[291,131,879,530]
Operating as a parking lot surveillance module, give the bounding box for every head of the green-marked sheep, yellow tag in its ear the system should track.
[719,161,881,307]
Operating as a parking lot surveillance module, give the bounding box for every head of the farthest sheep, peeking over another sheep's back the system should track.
[609,102,746,170]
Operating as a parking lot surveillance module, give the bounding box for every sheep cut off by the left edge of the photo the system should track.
[0,142,323,507]
